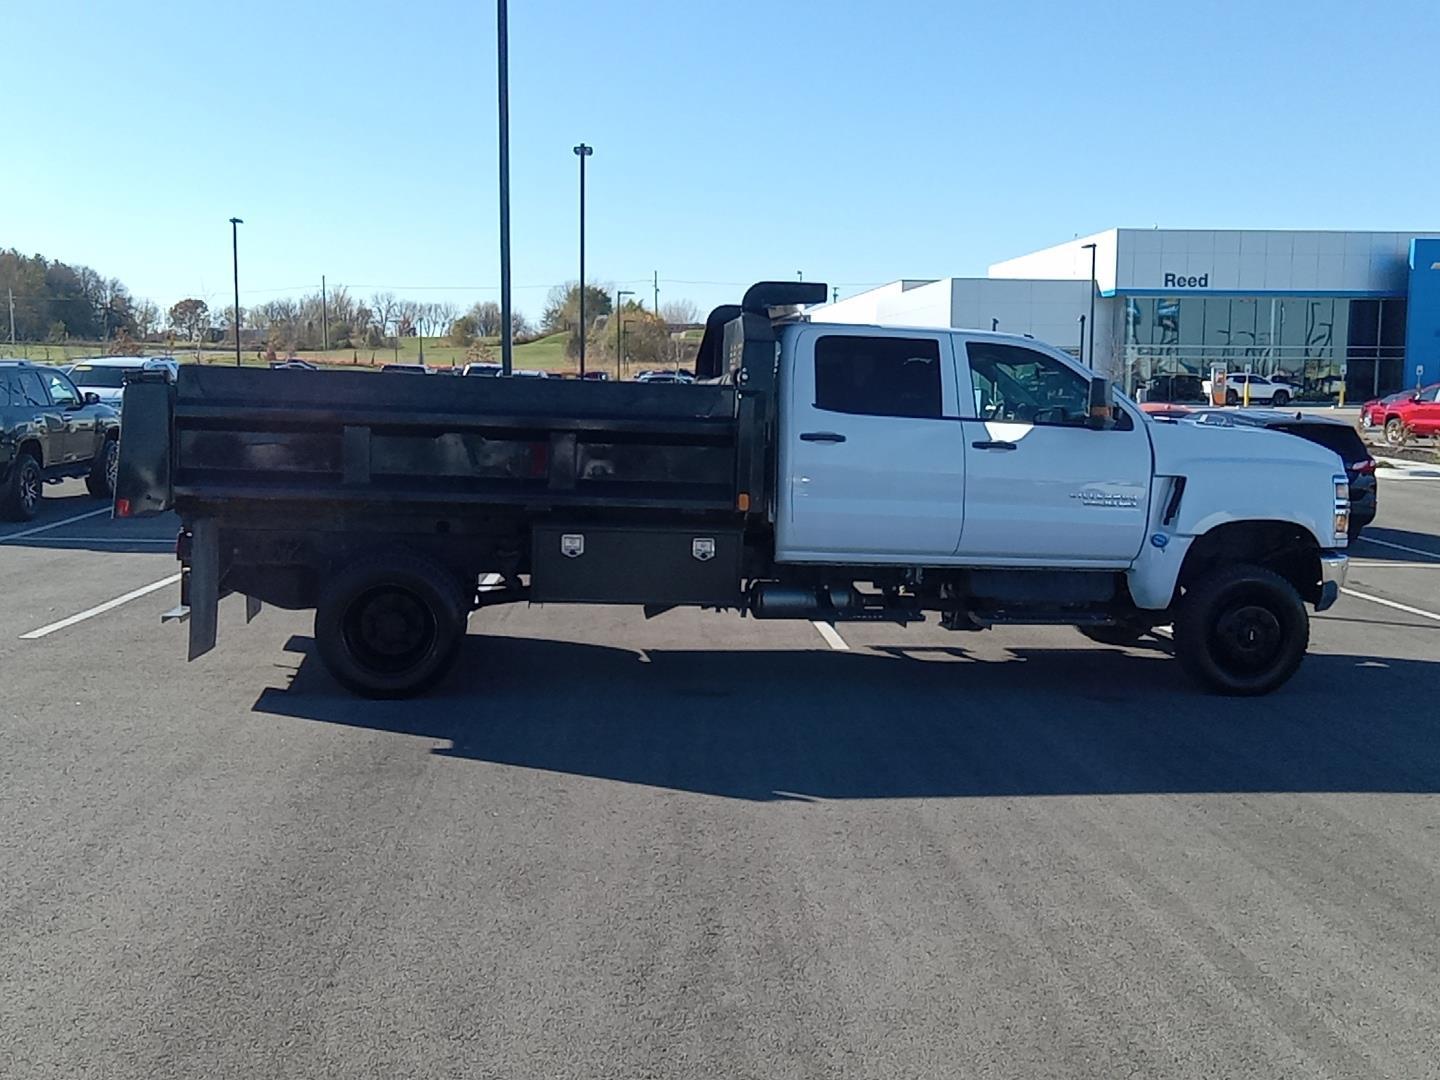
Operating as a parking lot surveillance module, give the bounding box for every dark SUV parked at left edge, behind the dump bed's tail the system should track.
[0,360,120,521]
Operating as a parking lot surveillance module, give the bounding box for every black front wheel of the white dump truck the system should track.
[1175,563,1310,697]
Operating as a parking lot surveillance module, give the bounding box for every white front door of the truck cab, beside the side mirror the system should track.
[956,336,1152,567]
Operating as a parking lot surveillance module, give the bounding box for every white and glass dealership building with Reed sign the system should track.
[808,229,1440,400]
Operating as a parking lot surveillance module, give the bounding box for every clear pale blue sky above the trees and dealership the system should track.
[0,0,1440,318]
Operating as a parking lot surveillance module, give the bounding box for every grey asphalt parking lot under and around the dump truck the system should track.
[0,475,1440,1080]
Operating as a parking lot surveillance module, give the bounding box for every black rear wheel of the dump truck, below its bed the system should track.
[315,553,469,698]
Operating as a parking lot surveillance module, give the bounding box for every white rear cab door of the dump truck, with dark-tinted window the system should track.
[776,327,965,563]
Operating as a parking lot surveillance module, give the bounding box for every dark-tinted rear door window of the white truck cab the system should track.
[815,334,940,419]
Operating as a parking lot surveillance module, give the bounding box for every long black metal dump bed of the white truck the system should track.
[120,366,736,513]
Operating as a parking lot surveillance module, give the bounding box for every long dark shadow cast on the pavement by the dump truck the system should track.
[255,635,1440,801]
